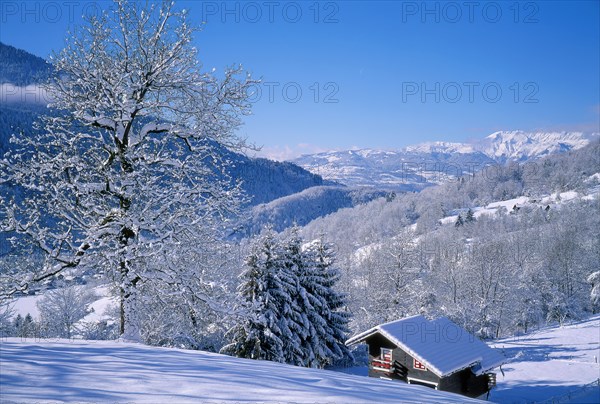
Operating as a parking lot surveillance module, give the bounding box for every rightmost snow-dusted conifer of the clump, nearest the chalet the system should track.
[299,237,351,368]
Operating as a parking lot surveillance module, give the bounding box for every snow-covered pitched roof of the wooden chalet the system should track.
[346,316,505,377]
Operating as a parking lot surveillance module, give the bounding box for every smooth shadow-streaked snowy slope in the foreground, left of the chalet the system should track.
[0,339,480,403]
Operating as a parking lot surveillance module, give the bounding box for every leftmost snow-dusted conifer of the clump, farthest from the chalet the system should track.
[221,228,290,362]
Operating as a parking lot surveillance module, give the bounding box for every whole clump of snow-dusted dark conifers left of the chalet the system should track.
[222,228,350,367]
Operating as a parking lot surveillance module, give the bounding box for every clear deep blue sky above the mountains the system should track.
[0,1,600,158]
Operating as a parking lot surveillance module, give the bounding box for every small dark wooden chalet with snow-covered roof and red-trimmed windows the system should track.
[346,316,505,398]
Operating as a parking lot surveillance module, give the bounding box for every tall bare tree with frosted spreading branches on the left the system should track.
[0,0,253,339]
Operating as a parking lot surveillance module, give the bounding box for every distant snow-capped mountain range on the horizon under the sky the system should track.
[292,131,600,191]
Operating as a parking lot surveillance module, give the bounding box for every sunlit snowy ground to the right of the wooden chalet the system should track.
[491,316,600,403]
